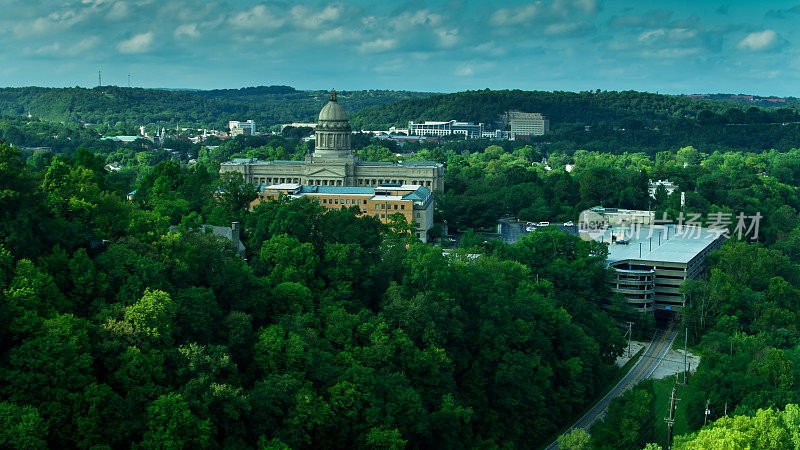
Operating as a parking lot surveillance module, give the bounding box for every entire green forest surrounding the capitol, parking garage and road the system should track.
[0,86,800,449]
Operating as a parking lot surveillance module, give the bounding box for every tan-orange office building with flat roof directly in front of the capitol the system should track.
[250,183,433,242]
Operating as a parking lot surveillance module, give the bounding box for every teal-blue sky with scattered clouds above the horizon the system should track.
[0,0,800,97]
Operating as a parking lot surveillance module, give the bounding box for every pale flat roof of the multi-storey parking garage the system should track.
[592,225,725,263]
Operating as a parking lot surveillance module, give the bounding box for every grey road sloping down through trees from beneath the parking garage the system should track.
[545,322,678,450]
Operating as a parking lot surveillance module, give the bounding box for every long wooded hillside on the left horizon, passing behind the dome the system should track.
[0,86,431,128]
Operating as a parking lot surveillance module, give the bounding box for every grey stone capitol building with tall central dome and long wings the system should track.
[219,91,444,192]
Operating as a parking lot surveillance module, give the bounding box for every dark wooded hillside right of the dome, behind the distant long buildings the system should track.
[351,89,796,129]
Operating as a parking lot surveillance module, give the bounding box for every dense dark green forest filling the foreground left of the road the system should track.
[0,145,622,448]
